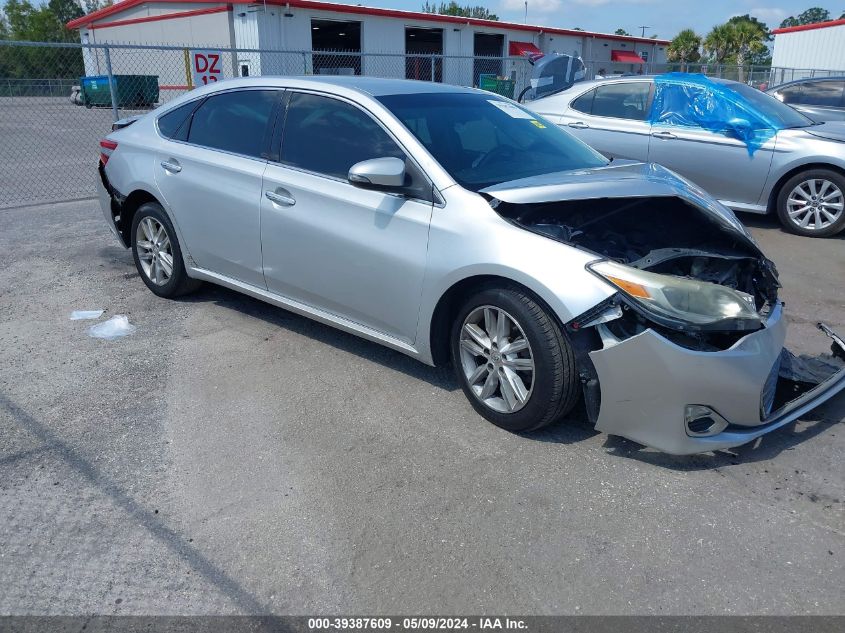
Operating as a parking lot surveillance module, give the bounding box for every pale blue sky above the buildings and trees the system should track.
[370,0,845,39]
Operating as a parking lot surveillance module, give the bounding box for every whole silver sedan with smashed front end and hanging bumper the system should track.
[98,77,845,453]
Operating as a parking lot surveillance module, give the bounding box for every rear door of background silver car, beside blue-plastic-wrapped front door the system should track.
[561,81,652,161]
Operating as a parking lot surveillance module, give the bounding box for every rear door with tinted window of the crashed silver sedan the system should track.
[155,89,282,288]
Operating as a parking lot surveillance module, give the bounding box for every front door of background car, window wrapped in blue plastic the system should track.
[648,82,776,207]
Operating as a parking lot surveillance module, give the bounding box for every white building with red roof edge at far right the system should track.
[772,20,845,73]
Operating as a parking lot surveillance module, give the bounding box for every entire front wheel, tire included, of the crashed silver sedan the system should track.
[451,287,578,431]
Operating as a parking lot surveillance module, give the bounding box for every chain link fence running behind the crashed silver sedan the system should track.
[0,41,844,208]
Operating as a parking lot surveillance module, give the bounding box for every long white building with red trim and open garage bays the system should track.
[68,0,669,100]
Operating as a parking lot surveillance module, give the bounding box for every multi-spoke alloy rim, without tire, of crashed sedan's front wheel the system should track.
[459,305,534,413]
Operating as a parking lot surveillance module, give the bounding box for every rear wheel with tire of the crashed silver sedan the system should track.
[132,202,201,298]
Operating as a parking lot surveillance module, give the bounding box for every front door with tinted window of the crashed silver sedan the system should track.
[261,92,433,343]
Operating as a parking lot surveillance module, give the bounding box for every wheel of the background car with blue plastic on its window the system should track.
[777,169,845,237]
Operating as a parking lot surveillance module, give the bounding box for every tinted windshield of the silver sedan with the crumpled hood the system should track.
[378,93,607,191]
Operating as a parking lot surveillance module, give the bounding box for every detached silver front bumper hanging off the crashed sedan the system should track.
[590,305,845,455]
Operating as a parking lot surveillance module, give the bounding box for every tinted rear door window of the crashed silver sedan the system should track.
[188,90,282,158]
